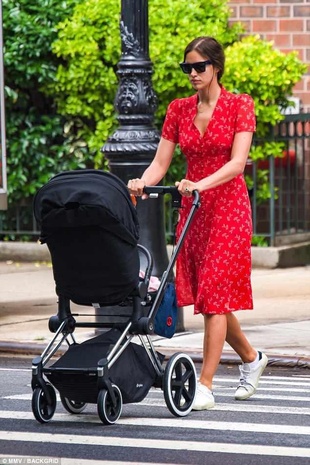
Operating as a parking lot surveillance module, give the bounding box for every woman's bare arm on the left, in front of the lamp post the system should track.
[128,137,176,196]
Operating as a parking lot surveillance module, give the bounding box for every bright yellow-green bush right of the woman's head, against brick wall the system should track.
[223,36,307,203]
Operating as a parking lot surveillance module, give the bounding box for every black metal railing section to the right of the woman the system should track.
[247,114,310,246]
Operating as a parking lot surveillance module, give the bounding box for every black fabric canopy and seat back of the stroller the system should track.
[34,170,140,305]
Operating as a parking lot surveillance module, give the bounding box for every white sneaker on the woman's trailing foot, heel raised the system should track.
[235,352,268,400]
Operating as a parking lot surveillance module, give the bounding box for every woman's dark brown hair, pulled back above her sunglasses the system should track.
[184,36,225,82]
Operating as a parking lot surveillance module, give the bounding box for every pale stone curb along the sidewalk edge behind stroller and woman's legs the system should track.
[0,341,310,369]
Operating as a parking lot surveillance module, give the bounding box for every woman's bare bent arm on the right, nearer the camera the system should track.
[176,132,253,195]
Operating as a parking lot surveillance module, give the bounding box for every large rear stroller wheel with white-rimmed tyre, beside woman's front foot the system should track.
[163,353,197,417]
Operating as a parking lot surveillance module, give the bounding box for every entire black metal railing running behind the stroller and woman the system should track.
[0,114,310,246]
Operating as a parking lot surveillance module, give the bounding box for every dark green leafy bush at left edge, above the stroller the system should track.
[2,0,85,203]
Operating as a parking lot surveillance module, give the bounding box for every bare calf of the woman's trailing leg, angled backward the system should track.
[226,313,257,363]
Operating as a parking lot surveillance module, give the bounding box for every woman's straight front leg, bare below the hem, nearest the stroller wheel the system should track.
[200,315,227,390]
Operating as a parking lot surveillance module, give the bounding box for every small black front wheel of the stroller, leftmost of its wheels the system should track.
[32,383,57,423]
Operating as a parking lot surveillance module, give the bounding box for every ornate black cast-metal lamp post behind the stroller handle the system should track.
[102,0,168,276]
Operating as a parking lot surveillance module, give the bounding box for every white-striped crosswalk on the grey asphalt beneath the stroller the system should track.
[0,370,310,465]
